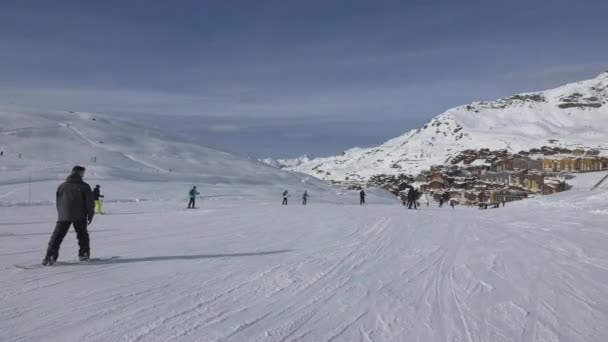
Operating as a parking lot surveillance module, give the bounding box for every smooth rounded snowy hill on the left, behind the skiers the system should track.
[0,107,342,205]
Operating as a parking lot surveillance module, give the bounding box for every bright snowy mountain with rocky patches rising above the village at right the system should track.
[289,71,608,181]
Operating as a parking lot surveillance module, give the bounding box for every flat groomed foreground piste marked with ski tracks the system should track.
[0,190,608,342]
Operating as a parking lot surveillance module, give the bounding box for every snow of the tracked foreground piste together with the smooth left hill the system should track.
[0,105,608,342]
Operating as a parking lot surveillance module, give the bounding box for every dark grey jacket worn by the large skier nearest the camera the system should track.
[57,175,95,221]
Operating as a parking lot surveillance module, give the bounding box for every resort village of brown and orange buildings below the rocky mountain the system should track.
[344,146,608,208]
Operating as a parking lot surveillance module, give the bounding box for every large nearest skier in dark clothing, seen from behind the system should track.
[42,166,95,266]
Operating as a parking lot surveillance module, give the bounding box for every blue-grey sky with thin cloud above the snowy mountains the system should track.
[0,0,608,158]
